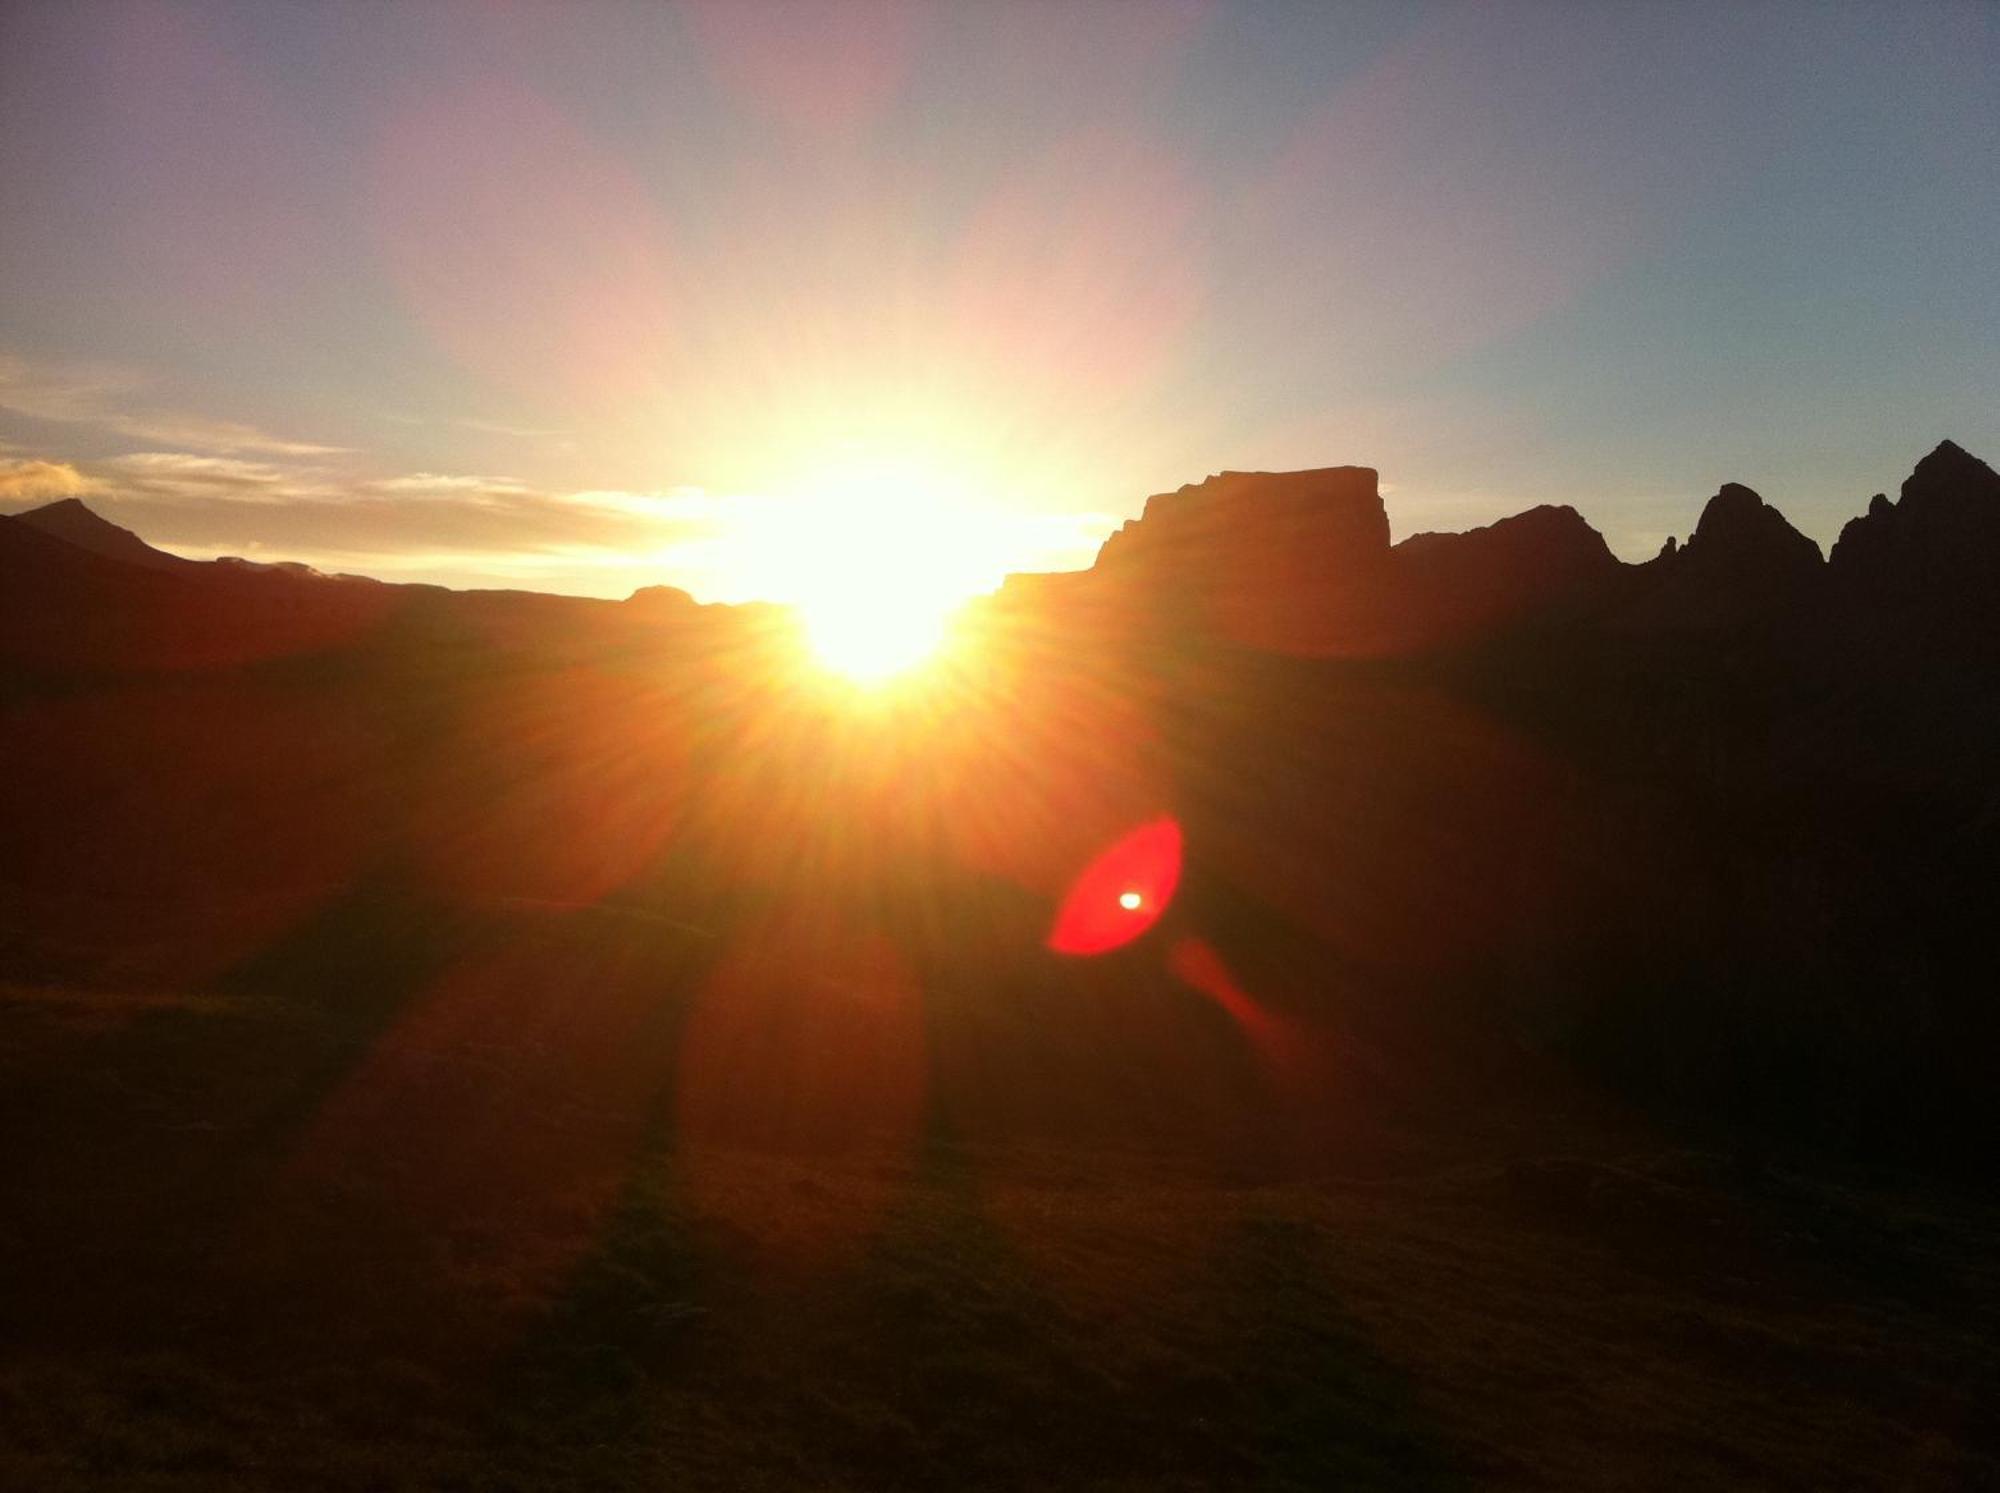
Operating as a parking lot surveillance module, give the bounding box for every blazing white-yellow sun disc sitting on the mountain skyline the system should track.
[784,448,1006,684]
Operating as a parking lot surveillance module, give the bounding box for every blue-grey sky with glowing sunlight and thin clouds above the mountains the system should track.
[0,0,2000,600]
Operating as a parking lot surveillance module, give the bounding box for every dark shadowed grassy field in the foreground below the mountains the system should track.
[0,929,2000,1489]
